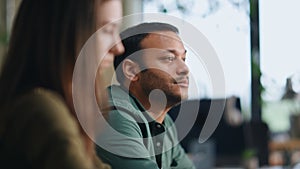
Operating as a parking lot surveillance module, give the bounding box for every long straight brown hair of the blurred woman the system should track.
[0,0,96,158]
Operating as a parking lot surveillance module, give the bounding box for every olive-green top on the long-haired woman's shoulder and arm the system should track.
[0,88,90,168]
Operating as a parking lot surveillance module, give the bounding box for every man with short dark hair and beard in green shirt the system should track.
[98,23,194,169]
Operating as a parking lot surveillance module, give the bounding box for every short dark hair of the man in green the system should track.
[114,22,179,83]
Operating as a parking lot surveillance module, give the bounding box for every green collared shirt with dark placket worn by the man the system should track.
[97,86,195,169]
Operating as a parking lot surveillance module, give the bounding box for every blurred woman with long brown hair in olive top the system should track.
[0,0,124,169]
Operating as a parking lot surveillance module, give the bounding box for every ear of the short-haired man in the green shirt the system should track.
[122,59,140,81]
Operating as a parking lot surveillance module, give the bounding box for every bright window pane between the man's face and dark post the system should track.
[143,0,251,115]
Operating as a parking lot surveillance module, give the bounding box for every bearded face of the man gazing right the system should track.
[138,31,189,103]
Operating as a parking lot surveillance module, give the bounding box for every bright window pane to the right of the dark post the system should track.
[259,0,300,133]
